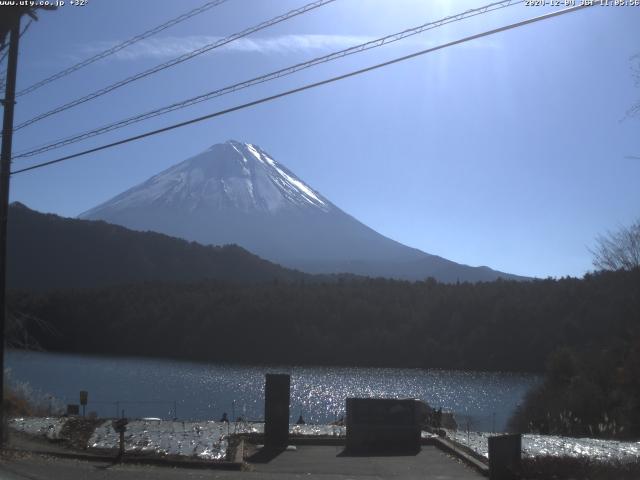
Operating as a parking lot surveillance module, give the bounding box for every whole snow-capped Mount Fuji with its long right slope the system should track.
[80,140,524,282]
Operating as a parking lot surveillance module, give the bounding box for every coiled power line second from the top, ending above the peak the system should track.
[14,0,335,131]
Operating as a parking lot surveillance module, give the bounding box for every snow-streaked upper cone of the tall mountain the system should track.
[81,140,334,218]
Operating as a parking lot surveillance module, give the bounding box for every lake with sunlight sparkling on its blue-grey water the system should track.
[5,350,541,431]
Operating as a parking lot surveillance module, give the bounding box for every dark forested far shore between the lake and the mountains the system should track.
[10,270,640,371]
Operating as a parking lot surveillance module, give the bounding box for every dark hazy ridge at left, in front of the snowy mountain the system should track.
[7,203,309,289]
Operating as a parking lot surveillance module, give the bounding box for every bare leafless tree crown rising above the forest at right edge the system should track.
[590,219,640,270]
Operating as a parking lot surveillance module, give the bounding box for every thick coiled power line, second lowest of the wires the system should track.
[13,0,524,160]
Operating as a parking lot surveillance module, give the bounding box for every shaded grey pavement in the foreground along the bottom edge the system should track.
[0,446,484,480]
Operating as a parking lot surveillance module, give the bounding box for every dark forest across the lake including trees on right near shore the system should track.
[8,221,640,438]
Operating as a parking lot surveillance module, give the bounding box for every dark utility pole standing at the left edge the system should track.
[0,2,55,446]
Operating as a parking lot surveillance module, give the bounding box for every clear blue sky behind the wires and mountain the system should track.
[5,0,640,277]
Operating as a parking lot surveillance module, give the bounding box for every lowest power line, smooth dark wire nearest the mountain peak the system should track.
[11,2,596,175]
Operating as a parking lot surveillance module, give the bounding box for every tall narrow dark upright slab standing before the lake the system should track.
[264,373,291,448]
